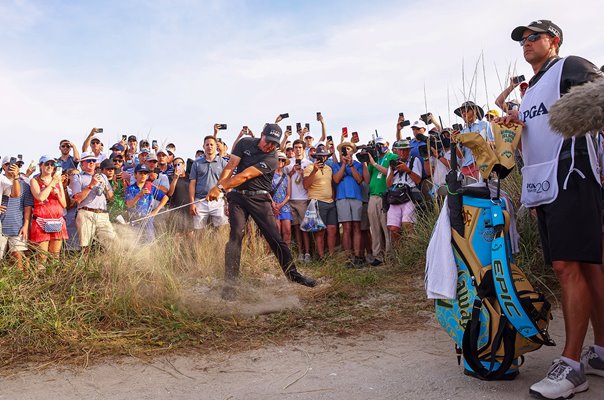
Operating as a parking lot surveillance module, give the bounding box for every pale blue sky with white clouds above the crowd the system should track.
[0,0,604,163]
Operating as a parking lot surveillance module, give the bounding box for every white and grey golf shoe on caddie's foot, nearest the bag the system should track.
[529,360,589,399]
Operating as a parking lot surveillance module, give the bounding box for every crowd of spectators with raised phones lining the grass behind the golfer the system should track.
[0,94,528,268]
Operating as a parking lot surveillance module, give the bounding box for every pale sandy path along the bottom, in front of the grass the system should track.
[0,317,604,400]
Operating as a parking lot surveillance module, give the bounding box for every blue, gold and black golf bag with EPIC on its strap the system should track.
[435,187,555,380]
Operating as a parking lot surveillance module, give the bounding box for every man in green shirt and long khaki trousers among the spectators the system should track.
[363,137,398,267]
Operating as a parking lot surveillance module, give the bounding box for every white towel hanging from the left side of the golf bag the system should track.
[424,199,457,300]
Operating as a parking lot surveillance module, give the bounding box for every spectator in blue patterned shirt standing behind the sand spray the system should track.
[124,164,169,244]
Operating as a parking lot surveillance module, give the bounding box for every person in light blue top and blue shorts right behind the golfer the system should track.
[271,152,292,246]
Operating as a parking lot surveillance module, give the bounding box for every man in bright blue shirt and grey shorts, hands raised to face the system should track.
[332,142,365,268]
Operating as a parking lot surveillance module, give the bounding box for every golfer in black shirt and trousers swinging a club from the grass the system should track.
[207,124,316,300]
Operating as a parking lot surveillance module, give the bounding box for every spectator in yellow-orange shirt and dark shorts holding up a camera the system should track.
[302,145,338,258]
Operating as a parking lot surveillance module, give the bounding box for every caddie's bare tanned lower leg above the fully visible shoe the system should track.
[552,261,593,361]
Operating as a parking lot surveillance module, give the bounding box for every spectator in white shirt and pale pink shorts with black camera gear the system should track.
[386,140,422,245]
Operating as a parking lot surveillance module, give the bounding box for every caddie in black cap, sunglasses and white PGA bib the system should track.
[497,20,604,399]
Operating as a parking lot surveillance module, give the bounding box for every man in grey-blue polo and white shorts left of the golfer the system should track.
[189,136,228,230]
